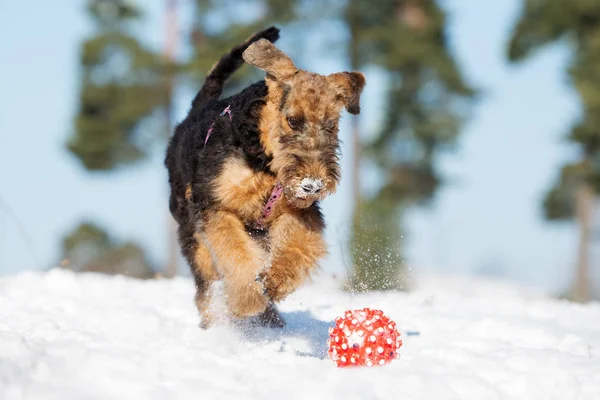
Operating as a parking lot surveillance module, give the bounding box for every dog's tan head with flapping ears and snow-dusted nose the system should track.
[243,39,365,208]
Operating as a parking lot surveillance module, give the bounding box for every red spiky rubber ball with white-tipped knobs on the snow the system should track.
[327,308,402,367]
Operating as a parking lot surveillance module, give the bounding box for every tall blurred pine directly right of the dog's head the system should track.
[343,0,474,290]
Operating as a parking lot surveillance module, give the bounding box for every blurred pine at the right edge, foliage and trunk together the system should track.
[508,0,600,301]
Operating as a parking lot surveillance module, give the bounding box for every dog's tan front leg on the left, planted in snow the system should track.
[204,211,268,318]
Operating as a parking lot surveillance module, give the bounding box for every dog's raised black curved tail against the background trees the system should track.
[192,26,279,108]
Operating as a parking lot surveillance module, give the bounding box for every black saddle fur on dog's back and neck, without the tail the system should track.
[165,81,271,224]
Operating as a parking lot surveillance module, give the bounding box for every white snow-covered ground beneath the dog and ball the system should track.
[0,270,600,400]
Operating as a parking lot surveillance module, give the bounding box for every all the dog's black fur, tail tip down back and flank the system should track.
[165,27,279,291]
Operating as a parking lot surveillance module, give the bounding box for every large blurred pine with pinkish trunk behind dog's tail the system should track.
[67,0,295,276]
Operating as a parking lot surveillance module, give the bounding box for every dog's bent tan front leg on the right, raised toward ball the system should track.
[259,214,327,301]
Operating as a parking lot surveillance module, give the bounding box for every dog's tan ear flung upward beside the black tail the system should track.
[242,39,298,82]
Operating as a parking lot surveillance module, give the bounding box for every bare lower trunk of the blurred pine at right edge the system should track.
[573,184,594,302]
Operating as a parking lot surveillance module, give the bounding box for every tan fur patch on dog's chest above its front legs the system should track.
[214,157,277,222]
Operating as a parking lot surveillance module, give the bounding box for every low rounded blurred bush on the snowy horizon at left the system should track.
[61,222,155,279]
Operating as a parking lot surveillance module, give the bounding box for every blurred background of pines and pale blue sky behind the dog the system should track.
[0,0,600,301]
